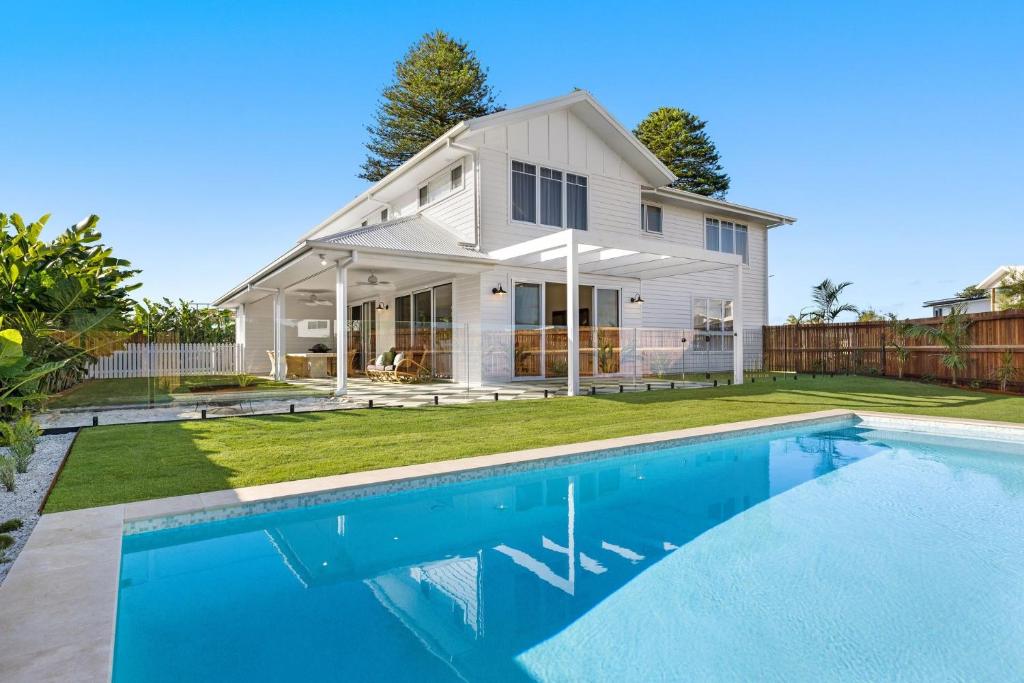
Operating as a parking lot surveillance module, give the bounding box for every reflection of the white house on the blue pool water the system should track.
[267,444,770,674]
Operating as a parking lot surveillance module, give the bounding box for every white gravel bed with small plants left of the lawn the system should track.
[0,433,75,584]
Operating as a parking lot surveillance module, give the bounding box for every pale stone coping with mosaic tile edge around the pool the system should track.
[0,410,1024,682]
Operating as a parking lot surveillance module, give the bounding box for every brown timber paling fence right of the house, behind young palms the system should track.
[762,310,1024,387]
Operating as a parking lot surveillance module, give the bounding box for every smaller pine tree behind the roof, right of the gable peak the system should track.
[633,106,729,199]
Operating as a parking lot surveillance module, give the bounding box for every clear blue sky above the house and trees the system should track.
[0,0,1024,322]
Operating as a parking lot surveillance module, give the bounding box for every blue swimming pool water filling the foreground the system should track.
[114,425,1024,683]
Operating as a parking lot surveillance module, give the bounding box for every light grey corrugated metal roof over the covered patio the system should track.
[316,214,487,260]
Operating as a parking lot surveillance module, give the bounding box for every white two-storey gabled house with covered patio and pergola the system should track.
[215,91,794,394]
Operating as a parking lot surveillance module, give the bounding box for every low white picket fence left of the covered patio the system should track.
[89,344,243,379]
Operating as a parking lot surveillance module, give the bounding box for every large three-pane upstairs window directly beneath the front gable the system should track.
[512,161,587,230]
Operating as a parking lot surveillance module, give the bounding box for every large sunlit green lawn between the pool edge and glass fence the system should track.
[46,377,1024,512]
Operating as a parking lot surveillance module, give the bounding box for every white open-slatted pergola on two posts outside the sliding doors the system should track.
[488,229,743,396]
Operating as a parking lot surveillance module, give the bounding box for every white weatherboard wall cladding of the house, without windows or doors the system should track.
[220,92,793,383]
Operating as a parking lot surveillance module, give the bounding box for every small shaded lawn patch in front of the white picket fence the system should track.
[49,375,309,409]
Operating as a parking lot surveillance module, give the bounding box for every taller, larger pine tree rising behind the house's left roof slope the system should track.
[359,31,502,181]
